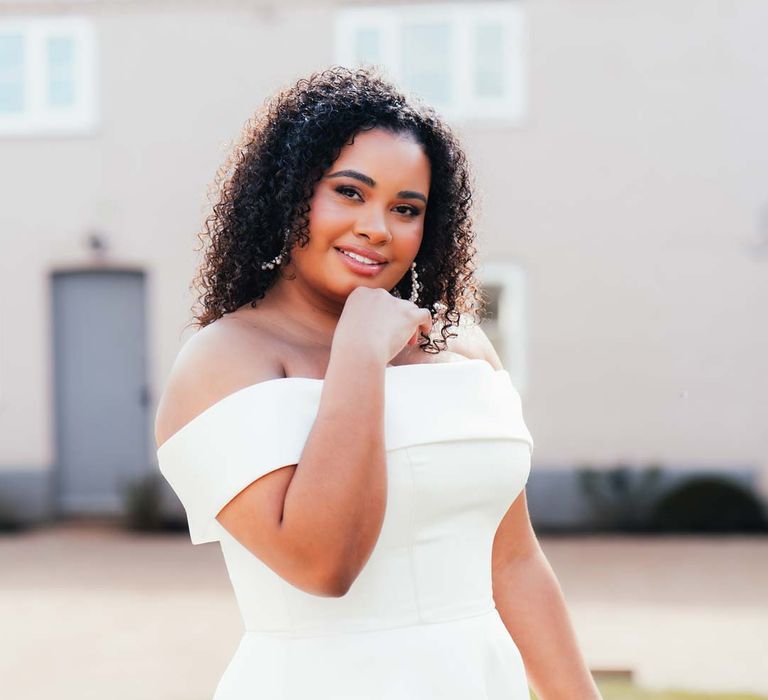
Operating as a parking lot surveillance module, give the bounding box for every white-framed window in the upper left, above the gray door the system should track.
[0,17,96,136]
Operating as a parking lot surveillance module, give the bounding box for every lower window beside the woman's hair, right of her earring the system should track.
[477,262,528,395]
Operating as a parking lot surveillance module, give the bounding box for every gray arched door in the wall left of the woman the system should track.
[52,271,150,515]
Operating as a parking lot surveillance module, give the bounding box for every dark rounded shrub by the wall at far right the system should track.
[650,477,768,532]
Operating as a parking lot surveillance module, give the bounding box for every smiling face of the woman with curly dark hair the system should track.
[291,129,431,300]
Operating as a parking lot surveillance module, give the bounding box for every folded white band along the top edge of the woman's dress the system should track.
[157,360,533,544]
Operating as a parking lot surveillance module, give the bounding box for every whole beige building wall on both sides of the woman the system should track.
[0,0,768,492]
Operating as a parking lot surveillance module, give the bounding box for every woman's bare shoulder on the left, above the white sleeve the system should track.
[155,316,285,447]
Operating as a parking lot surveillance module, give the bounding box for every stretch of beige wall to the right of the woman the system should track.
[470,0,768,476]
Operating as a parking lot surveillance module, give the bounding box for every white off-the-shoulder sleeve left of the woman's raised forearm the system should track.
[157,378,322,544]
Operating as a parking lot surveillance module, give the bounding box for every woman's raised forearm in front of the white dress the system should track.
[282,351,387,589]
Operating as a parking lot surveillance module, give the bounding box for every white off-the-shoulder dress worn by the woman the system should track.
[157,359,533,700]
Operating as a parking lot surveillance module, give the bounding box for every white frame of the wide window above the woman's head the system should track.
[334,0,528,125]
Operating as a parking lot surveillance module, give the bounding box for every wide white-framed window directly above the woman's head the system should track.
[336,1,526,123]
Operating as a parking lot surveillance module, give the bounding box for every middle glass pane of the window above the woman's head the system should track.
[403,23,453,106]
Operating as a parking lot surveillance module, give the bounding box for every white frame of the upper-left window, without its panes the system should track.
[0,16,98,138]
